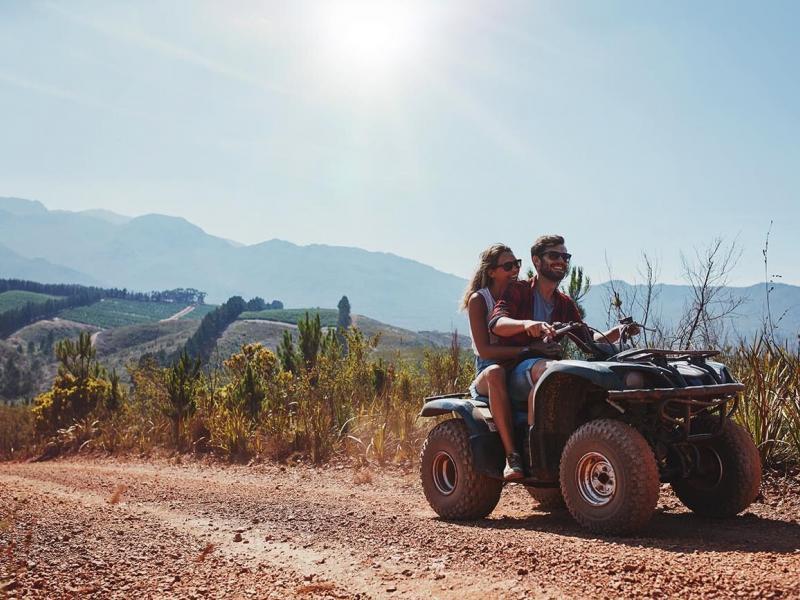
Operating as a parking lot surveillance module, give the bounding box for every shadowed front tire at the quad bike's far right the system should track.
[672,419,761,517]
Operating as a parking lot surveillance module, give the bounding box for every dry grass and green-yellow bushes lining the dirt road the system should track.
[0,315,800,469]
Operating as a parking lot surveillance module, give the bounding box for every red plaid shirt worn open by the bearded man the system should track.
[489,277,582,346]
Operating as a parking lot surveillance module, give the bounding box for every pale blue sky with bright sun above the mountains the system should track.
[0,0,800,285]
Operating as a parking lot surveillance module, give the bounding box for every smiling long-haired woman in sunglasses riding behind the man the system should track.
[461,244,528,481]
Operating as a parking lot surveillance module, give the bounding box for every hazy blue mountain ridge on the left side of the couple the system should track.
[0,198,466,331]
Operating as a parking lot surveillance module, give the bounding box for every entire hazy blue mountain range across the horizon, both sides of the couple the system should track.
[0,197,800,341]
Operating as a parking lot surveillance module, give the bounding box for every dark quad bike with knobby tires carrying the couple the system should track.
[420,318,761,534]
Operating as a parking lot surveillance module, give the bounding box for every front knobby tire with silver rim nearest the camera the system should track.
[559,419,660,534]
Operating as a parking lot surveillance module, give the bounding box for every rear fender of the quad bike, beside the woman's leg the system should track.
[419,398,505,479]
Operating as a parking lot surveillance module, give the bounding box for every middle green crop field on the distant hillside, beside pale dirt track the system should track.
[59,298,194,329]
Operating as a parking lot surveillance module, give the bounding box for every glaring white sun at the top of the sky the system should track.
[315,0,429,86]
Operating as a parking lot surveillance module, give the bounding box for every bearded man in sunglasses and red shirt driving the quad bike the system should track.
[489,235,632,425]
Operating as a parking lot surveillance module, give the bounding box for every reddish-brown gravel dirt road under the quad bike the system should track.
[0,459,800,599]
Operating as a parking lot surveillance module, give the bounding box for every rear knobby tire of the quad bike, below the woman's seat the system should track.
[419,419,503,520]
